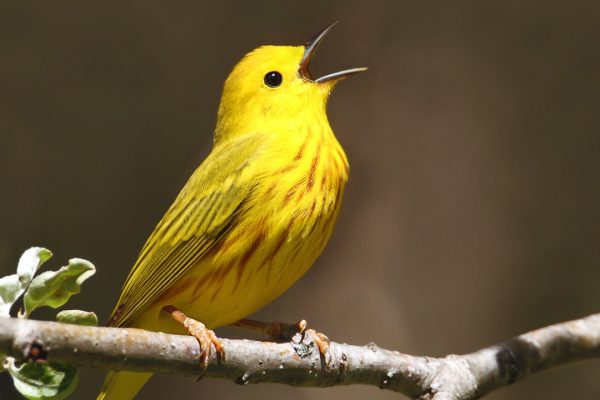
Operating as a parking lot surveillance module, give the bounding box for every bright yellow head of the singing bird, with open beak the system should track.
[215,24,366,144]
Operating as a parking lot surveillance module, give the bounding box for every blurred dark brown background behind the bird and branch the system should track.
[0,0,600,400]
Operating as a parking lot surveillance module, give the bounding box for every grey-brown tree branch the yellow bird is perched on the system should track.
[0,314,600,400]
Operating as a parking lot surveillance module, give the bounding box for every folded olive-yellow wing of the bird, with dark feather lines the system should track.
[108,134,265,326]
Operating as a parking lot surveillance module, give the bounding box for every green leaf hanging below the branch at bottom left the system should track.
[8,363,79,400]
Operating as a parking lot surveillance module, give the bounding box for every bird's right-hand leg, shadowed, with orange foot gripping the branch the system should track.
[232,319,329,356]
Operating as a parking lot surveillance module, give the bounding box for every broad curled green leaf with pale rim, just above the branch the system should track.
[24,258,96,316]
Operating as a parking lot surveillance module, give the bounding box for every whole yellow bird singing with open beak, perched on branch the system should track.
[98,24,366,400]
